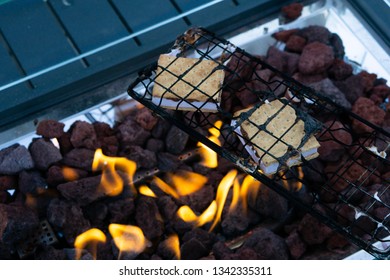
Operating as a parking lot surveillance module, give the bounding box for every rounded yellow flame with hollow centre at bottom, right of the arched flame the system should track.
[108,224,149,255]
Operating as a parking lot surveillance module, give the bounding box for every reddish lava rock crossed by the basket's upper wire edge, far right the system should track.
[352,97,386,133]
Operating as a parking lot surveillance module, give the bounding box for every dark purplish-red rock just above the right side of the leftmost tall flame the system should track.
[117,118,150,146]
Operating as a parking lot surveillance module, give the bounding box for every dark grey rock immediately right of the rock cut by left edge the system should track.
[29,138,62,171]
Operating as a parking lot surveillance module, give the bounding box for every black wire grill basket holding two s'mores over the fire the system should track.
[128,29,390,259]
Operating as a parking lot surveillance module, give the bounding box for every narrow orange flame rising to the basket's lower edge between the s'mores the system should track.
[198,121,222,168]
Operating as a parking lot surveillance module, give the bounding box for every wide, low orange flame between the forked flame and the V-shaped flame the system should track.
[153,170,207,199]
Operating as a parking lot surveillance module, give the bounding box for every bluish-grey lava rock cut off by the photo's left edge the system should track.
[0,144,34,175]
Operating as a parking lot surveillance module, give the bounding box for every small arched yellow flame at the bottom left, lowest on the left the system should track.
[74,228,107,260]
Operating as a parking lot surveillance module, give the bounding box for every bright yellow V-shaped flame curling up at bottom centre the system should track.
[177,200,217,227]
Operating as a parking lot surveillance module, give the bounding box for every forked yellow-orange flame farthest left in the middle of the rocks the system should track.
[92,149,137,196]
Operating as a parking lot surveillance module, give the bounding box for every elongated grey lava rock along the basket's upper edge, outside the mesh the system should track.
[309,78,352,110]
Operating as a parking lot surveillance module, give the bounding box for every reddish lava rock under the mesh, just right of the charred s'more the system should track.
[318,121,352,161]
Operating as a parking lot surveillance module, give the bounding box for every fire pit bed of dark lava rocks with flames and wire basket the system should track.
[0,0,390,259]
